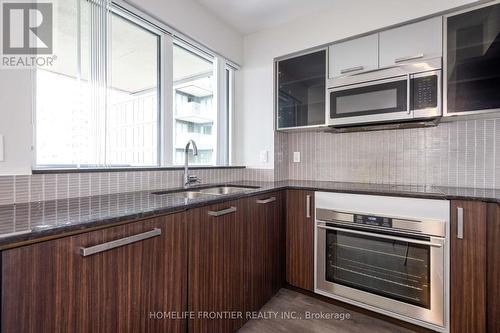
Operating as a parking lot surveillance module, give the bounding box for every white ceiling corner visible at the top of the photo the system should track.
[196,0,338,34]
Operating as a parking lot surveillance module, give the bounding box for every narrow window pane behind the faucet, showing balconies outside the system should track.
[173,44,217,165]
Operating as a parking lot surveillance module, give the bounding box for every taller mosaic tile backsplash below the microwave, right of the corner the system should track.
[275,119,500,188]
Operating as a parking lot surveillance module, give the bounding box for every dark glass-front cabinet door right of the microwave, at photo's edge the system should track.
[445,4,500,114]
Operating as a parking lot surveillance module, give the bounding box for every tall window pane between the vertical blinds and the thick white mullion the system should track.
[106,15,159,166]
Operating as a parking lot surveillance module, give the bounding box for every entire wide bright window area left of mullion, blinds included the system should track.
[36,0,160,167]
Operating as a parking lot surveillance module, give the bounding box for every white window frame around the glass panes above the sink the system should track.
[30,0,240,171]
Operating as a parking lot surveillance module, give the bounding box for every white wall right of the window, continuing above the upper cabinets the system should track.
[236,0,482,168]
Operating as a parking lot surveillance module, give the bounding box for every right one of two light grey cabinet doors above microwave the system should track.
[380,16,443,68]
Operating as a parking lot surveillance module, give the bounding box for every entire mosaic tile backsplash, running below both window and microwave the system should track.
[0,118,500,205]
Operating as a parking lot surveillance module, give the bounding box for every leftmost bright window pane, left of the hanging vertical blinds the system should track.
[36,0,88,166]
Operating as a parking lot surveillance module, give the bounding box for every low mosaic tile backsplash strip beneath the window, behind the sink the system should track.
[0,168,274,205]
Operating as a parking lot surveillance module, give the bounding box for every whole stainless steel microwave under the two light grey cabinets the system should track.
[328,58,442,127]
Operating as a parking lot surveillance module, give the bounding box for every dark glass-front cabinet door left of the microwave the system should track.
[276,49,327,129]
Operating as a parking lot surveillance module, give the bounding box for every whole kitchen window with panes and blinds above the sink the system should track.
[34,0,233,169]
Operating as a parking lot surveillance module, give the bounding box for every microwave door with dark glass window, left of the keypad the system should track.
[330,76,409,119]
